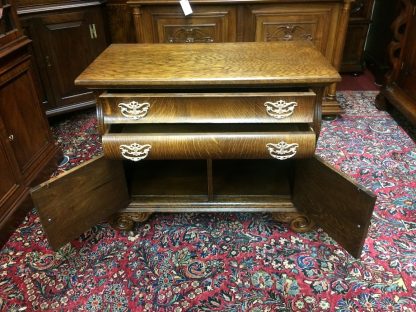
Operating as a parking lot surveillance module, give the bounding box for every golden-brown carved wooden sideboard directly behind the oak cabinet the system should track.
[107,0,352,115]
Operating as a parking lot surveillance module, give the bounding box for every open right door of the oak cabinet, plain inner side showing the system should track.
[293,156,376,258]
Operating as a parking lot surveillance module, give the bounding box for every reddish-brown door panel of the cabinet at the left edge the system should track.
[0,60,50,176]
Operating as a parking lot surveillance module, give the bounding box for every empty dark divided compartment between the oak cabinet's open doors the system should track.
[125,159,294,211]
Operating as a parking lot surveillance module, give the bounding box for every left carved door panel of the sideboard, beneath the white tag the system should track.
[143,6,236,43]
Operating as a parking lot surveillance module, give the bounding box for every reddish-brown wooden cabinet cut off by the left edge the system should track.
[0,0,60,245]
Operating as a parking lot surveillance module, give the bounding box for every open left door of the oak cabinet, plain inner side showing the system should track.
[31,157,129,250]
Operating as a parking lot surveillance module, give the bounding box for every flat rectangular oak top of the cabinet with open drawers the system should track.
[75,41,341,88]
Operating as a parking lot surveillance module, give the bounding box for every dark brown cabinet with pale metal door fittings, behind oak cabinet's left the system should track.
[17,0,108,116]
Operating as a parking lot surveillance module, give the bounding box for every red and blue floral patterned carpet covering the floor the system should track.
[0,92,416,312]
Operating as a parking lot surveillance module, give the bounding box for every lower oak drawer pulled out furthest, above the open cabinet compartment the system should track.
[102,124,316,161]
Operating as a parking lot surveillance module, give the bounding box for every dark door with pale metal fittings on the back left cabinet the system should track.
[32,9,107,111]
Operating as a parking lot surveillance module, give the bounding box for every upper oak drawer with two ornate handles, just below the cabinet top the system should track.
[100,91,316,124]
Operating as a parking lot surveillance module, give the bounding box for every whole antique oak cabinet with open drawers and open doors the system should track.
[32,42,374,257]
